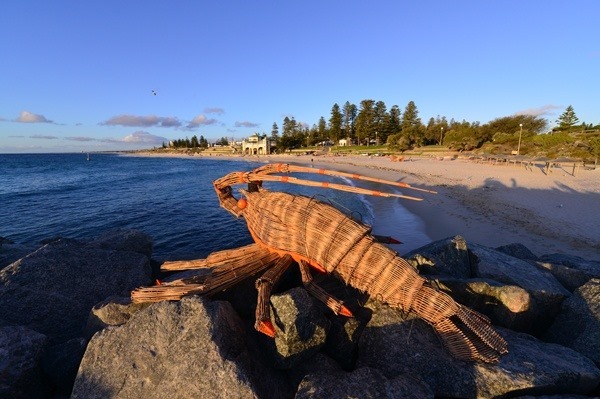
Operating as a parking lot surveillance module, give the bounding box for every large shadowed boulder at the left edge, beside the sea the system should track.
[0,239,151,344]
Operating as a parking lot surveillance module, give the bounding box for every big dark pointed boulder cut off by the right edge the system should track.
[543,279,600,367]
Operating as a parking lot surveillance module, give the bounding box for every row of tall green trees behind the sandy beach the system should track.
[271,100,600,151]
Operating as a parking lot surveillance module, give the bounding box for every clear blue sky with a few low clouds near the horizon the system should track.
[0,0,600,153]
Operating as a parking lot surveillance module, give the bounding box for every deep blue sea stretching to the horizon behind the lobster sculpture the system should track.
[0,153,427,260]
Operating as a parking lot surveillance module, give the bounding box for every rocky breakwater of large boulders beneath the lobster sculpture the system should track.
[0,232,600,398]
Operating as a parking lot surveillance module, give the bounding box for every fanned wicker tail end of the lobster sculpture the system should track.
[411,285,508,363]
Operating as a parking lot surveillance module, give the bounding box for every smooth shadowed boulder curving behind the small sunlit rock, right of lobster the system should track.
[469,244,571,335]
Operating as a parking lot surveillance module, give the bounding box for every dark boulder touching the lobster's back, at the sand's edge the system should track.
[403,236,472,278]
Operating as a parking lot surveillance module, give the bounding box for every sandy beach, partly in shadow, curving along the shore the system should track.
[131,155,600,261]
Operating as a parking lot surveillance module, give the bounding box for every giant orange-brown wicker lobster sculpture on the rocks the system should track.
[132,164,508,363]
